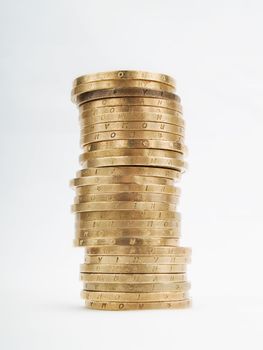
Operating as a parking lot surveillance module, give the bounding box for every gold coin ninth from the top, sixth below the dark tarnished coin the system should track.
[83,140,188,155]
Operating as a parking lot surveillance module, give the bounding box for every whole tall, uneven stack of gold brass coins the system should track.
[71,71,191,310]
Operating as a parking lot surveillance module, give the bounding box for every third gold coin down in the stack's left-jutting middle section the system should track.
[76,184,180,196]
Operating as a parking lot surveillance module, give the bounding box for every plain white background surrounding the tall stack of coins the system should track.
[0,0,263,350]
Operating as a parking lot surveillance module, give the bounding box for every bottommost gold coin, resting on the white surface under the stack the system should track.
[85,299,191,311]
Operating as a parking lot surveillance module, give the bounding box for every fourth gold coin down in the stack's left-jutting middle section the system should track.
[74,192,179,204]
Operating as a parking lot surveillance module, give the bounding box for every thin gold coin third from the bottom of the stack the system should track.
[83,280,190,293]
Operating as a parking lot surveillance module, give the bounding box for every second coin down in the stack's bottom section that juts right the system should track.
[84,254,190,265]
